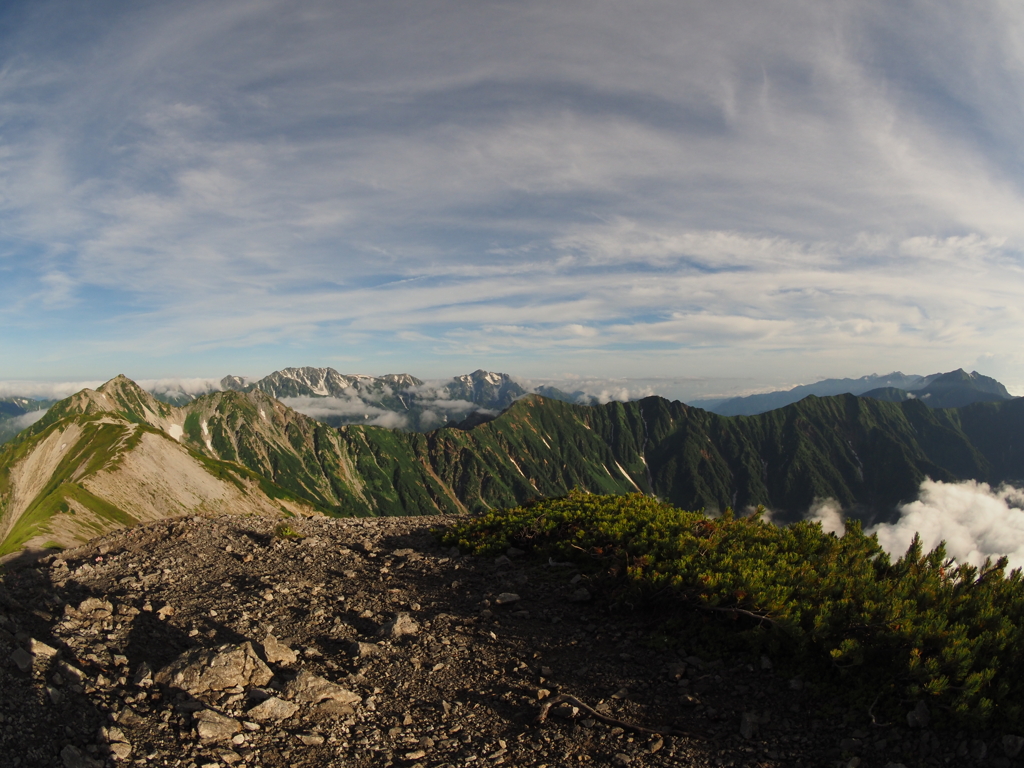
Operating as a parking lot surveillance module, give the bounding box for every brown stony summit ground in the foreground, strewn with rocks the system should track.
[0,516,1022,768]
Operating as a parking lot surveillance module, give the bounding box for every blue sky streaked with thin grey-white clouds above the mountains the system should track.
[0,0,1024,396]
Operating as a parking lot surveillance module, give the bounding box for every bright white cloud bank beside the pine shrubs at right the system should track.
[866,479,1024,568]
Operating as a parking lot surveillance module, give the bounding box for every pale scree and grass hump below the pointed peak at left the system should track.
[0,413,318,555]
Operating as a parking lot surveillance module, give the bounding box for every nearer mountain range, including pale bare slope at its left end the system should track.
[0,375,1024,554]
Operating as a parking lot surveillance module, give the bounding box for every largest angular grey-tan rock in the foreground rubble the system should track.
[155,642,273,695]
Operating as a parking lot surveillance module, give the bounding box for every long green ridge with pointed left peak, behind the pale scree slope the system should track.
[6,377,1024,557]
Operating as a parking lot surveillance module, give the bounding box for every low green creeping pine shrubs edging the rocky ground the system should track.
[439,492,1024,727]
